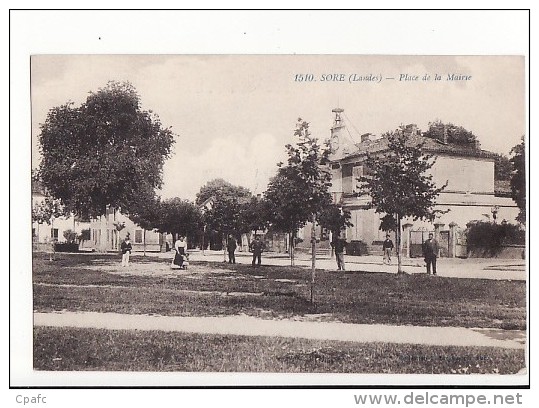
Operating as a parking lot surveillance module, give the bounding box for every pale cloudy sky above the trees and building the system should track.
[31,55,526,200]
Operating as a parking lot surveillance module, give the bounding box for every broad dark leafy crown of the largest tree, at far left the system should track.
[38,82,174,217]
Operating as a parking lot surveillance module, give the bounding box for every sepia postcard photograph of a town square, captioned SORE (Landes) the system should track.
[27,55,527,382]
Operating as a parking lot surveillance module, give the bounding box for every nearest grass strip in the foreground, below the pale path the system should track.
[34,327,524,374]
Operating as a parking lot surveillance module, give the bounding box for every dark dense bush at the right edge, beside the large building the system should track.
[466,221,526,256]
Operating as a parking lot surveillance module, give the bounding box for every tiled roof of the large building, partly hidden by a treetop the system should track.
[341,132,496,160]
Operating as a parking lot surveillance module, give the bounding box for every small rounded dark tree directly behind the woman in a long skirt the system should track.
[155,197,207,242]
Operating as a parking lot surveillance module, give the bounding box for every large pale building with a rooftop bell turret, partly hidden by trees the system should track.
[307,109,518,256]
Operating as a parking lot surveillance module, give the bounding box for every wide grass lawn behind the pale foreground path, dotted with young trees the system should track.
[33,254,526,329]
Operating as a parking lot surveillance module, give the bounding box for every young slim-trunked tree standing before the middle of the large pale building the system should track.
[359,132,447,273]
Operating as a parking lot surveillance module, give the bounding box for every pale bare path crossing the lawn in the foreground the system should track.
[34,311,526,349]
